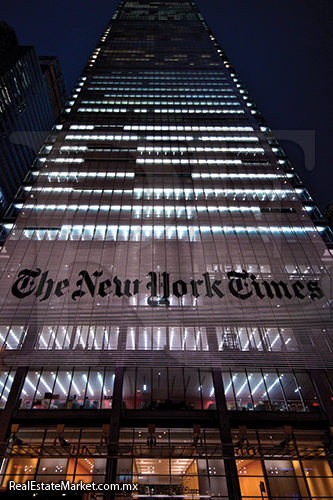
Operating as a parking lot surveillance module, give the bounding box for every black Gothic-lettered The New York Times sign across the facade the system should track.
[12,268,324,307]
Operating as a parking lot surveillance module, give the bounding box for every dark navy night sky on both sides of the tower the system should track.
[0,0,333,212]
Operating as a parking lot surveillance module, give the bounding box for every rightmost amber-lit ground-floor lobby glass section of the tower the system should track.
[233,428,333,500]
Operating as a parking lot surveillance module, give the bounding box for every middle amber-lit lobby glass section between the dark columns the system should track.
[117,428,228,499]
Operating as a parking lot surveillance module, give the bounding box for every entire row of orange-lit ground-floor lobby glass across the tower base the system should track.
[0,427,333,500]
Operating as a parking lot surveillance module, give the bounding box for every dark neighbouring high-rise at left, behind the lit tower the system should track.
[0,21,66,216]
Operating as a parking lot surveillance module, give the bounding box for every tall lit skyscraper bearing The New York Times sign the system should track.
[0,0,333,500]
